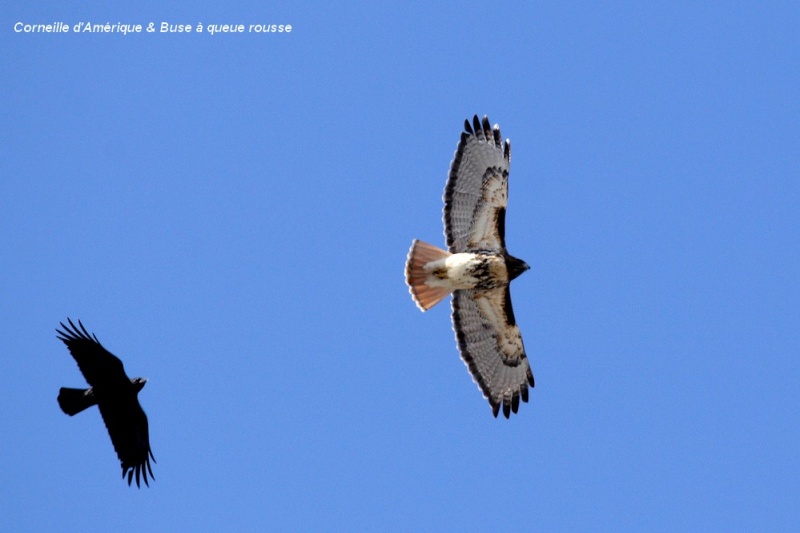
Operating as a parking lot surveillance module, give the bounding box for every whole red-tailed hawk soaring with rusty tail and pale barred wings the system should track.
[405,115,533,418]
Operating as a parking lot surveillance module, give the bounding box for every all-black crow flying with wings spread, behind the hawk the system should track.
[56,319,156,487]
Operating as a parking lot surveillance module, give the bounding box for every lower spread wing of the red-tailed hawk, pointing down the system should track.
[453,286,533,418]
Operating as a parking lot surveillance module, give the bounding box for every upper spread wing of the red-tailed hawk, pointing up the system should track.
[444,115,511,253]
